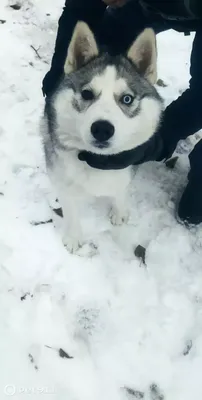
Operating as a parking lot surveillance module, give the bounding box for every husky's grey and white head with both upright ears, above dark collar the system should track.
[54,22,162,154]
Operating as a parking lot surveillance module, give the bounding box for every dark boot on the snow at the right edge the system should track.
[178,140,202,225]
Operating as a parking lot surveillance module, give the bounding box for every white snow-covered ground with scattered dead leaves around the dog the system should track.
[0,0,202,400]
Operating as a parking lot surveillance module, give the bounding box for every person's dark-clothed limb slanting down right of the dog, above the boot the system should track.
[158,29,202,159]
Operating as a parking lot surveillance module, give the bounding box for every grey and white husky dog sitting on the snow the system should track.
[42,22,162,253]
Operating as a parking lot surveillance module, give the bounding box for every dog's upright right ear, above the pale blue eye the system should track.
[127,28,157,85]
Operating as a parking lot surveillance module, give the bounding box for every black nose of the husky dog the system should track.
[91,120,115,143]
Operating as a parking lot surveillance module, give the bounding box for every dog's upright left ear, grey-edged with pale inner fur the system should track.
[64,22,98,74]
